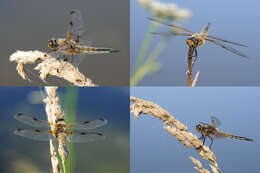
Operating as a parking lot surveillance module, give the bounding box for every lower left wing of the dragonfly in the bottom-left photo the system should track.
[14,129,55,141]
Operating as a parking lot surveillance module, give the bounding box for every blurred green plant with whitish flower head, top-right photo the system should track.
[130,0,191,86]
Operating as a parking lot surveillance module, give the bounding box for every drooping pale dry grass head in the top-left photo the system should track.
[10,50,96,86]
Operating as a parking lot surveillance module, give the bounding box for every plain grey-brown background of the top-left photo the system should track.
[0,0,130,86]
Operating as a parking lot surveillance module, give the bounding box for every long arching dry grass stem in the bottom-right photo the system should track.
[130,96,221,173]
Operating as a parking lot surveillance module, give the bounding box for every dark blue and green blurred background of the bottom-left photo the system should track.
[0,87,130,173]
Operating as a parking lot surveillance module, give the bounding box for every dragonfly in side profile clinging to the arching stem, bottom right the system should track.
[196,116,253,148]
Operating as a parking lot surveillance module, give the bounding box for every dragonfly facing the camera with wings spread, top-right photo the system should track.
[148,18,248,62]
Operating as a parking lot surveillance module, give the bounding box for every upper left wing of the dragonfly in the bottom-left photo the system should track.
[14,113,50,128]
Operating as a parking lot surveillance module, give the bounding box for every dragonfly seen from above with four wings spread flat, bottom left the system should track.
[15,113,107,143]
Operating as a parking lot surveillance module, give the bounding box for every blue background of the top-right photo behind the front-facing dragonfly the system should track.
[131,0,260,86]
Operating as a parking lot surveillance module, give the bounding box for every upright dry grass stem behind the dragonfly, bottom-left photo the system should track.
[43,87,68,173]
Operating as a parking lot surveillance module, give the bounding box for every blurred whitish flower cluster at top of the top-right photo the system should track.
[137,0,191,20]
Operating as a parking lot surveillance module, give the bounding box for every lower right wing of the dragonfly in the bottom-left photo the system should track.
[68,131,105,143]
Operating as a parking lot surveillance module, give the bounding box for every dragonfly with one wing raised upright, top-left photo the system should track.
[48,10,119,67]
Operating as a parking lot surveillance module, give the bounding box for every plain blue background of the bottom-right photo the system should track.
[130,87,260,173]
